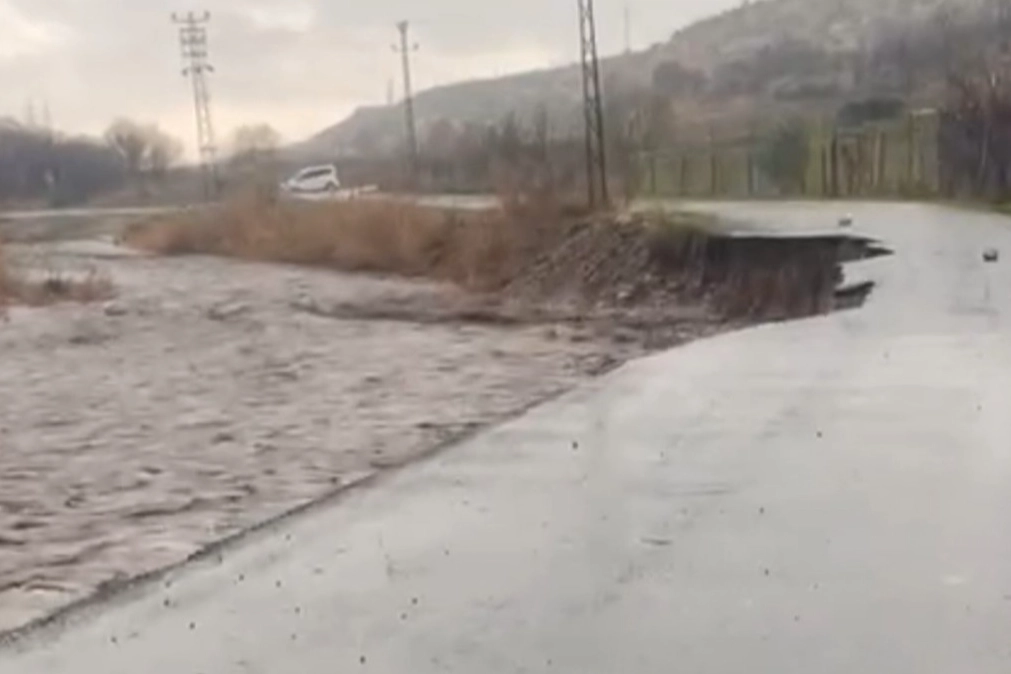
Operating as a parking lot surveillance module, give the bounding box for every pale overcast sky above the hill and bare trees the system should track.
[0,0,740,154]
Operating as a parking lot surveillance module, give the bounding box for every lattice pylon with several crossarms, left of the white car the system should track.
[172,12,218,199]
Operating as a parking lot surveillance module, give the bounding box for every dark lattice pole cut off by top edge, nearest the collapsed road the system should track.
[577,0,611,208]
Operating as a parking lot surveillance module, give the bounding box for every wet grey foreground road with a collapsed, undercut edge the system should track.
[0,204,1011,674]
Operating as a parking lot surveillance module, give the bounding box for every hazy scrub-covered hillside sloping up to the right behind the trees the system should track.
[291,0,1011,158]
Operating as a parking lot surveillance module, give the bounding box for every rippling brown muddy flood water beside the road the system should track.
[0,236,698,632]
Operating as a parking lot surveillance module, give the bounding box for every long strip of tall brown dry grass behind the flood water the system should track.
[124,194,560,291]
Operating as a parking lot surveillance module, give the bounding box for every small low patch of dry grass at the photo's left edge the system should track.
[0,237,114,312]
